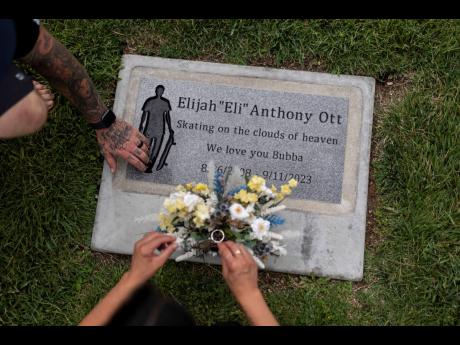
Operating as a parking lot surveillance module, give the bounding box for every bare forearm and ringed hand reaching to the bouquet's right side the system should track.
[218,241,279,326]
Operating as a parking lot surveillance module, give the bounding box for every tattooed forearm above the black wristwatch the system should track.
[21,27,107,123]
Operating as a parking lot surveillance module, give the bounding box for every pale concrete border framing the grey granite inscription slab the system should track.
[92,55,375,281]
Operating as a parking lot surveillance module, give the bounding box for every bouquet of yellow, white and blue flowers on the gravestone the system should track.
[149,162,297,269]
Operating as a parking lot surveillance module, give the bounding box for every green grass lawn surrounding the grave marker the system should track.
[0,20,460,325]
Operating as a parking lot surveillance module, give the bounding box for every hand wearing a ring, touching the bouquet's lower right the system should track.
[218,241,259,301]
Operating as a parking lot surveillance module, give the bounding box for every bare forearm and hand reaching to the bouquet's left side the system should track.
[80,232,177,326]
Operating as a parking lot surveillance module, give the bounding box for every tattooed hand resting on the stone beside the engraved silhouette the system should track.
[96,120,149,174]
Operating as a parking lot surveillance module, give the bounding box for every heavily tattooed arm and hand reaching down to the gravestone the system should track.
[20,25,148,173]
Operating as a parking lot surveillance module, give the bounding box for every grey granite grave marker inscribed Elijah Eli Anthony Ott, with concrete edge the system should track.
[92,55,374,280]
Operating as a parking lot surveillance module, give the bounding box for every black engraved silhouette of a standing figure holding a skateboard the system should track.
[139,85,176,173]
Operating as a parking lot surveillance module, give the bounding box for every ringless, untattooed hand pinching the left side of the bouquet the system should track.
[126,231,177,287]
